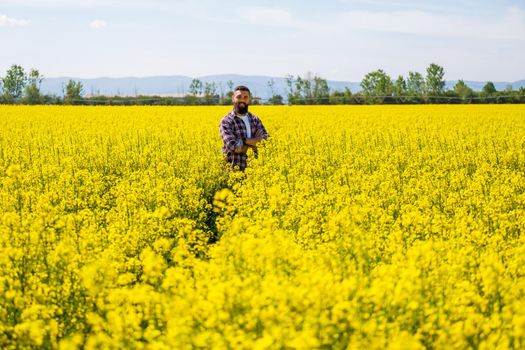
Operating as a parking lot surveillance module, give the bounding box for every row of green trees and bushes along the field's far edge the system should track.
[0,63,525,105]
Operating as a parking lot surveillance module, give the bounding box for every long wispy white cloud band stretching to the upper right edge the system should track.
[238,6,525,40]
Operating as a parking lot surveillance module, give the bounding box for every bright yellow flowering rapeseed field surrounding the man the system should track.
[0,105,525,349]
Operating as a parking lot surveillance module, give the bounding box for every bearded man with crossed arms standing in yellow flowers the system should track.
[219,85,268,171]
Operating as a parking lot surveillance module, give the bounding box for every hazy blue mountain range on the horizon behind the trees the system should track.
[41,74,525,99]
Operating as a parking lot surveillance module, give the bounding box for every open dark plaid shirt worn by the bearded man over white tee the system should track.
[219,110,268,170]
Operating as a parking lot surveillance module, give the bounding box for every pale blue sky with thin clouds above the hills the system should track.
[0,0,525,82]
